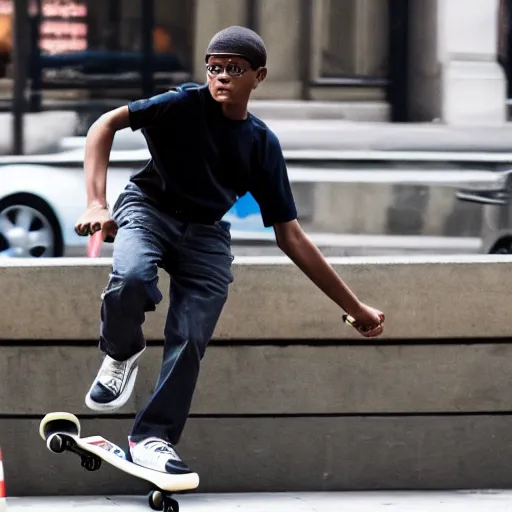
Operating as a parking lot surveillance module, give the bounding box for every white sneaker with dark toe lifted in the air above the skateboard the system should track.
[85,348,146,411]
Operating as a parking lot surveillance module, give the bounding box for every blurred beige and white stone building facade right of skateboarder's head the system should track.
[194,0,512,124]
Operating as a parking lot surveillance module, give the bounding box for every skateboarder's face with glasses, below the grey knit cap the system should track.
[206,55,266,104]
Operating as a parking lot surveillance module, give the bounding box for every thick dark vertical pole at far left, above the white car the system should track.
[12,0,29,155]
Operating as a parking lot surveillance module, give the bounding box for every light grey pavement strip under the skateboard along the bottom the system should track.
[5,490,512,512]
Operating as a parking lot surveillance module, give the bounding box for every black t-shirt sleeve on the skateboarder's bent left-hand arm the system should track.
[128,89,186,131]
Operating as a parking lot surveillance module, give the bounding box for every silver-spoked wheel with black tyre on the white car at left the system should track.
[0,194,63,258]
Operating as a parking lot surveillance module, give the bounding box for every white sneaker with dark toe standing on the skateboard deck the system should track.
[130,437,191,475]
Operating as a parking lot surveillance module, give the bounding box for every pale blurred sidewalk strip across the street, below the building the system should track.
[5,104,512,155]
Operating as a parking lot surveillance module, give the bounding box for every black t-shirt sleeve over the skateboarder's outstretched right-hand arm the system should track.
[250,128,297,227]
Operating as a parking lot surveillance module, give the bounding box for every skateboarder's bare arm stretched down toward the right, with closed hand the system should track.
[274,220,383,336]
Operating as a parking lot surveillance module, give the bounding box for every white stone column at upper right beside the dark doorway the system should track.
[409,0,506,125]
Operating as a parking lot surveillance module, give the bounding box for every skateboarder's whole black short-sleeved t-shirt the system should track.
[128,86,297,227]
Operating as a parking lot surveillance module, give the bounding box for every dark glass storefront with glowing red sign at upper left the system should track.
[0,0,194,110]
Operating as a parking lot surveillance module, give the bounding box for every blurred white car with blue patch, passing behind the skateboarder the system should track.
[0,137,266,258]
